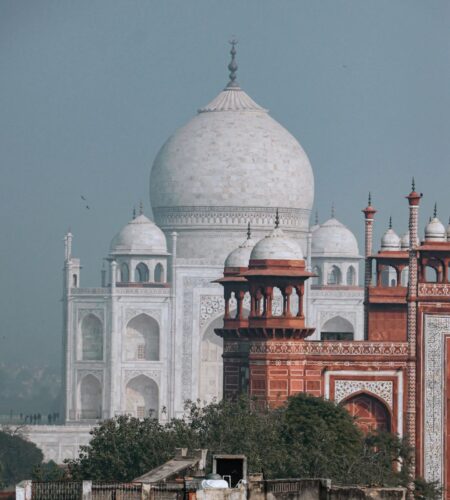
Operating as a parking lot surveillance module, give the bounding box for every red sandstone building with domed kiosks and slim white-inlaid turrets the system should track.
[216,184,450,498]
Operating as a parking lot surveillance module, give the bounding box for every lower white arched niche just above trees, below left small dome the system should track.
[125,375,159,418]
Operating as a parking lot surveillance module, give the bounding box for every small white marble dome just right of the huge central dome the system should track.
[311,217,359,258]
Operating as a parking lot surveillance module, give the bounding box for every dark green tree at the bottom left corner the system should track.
[0,430,43,487]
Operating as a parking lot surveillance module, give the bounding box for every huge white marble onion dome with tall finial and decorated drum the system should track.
[150,47,314,262]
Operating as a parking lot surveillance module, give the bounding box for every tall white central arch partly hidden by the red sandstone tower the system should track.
[199,317,223,402]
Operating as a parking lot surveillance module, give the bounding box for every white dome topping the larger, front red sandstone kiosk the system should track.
[250,227,303,260]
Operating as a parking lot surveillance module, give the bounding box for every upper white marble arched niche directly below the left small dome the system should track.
[124,313,159,361]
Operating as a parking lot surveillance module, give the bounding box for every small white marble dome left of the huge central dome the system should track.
[110,214,167,255]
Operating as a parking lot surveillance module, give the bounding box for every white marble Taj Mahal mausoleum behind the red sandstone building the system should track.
[59,43,363,423]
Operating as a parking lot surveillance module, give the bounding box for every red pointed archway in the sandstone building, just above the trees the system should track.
[341,392,391,434]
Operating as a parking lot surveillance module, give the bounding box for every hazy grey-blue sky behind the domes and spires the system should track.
[0,0,450,364]
